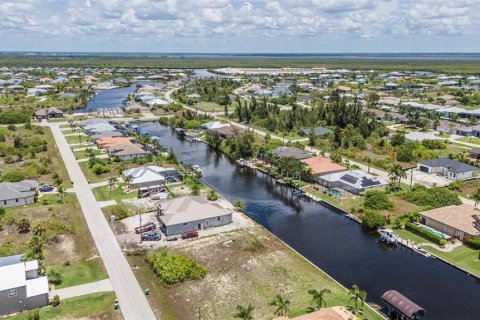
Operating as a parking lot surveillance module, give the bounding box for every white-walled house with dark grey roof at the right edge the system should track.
[417,158,480,181]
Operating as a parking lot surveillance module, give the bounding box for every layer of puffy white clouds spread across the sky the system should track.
[0,0,480,51]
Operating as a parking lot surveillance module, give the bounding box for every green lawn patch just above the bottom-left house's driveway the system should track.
[47,258,106,289]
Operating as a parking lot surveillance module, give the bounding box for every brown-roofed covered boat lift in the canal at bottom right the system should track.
[382,290,426,320]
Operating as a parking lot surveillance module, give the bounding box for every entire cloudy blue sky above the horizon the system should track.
[0,0,480,53]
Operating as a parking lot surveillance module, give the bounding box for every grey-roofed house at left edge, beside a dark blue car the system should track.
[0,180,37,208]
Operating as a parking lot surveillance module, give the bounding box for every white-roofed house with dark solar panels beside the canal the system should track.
[317,170,387,194]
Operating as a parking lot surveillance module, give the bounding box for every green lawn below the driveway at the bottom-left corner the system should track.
[5,292,119,320]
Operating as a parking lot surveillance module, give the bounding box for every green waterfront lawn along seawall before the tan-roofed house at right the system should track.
[395,229,480,277]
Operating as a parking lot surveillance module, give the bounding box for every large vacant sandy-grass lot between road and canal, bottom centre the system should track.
[129,227,379,319]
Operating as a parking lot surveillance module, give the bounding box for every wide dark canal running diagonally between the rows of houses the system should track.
[136,122,480,320]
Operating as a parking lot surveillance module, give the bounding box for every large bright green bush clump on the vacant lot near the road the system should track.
[147,250,207,287]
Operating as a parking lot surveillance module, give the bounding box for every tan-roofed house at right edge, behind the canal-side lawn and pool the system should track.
[420,204,480,241]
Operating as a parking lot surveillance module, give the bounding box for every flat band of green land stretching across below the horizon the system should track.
[0,56,480,73]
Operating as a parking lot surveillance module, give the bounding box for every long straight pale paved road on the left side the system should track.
[49,123,156,320]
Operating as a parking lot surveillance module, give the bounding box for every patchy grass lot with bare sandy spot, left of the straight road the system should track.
[0,193,107,287]
